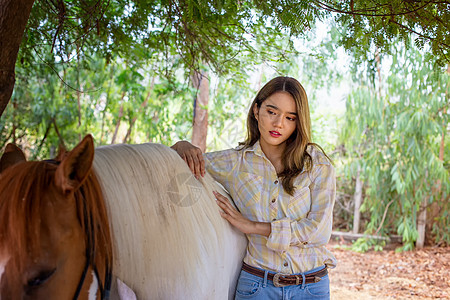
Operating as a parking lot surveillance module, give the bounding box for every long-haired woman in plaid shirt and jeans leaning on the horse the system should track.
[172,77,336,299]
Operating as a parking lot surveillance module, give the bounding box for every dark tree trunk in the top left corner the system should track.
[0,0,34,116]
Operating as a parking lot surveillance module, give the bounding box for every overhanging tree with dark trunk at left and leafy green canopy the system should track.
[0,0,450,115]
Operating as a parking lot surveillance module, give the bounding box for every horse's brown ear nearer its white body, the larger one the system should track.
[55,135,94,195]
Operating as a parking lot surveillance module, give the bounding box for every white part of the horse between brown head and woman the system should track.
[94,144,247,299]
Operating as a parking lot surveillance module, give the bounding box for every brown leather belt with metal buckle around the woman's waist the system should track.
[242,263,328,287]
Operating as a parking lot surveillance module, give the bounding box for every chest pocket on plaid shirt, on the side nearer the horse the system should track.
[234,172,263,207]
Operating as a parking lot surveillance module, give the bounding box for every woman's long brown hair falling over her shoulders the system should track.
[240,76,331,196]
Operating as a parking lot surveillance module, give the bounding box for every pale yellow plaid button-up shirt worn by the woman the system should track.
[204,142,336,274]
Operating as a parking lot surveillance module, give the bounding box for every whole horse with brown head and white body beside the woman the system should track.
[0,136,246,300]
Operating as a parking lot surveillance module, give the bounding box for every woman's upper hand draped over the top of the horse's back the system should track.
[170,141,205,179]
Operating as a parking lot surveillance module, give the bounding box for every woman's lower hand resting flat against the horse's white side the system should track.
[213,191,271,236]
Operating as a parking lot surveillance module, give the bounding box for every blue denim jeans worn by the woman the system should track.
[234,267,330,300]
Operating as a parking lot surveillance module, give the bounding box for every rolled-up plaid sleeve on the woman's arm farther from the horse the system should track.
[266,164,336,252]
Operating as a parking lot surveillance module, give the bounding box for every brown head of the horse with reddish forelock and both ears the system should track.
[0,136,112,299]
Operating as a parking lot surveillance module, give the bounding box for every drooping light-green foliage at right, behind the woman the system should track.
[341,44,450,250]
